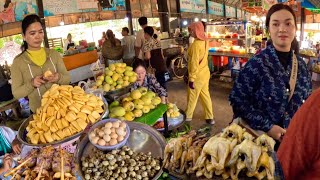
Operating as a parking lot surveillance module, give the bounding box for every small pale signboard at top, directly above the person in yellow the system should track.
[180,0,206,13]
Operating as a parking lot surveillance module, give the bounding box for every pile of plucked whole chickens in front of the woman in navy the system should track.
[163,123,275,180]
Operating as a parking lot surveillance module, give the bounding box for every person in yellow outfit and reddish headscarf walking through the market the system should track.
[186,22,215,124]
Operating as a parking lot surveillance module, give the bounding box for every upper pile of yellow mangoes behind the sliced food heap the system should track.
[96,63,137,92]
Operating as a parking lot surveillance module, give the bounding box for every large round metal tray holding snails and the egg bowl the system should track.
[75,121,166,180]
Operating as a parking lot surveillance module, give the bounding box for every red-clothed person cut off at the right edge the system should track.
[277,90,320,180]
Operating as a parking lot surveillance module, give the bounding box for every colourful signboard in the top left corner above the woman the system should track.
[0,0,38,24]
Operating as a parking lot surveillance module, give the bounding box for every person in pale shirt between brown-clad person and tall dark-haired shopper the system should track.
[121,27,136,66]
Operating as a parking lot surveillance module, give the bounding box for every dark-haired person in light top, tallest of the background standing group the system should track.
[134,17,148,59]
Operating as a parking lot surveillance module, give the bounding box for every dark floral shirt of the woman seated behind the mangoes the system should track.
[132,74,168,97]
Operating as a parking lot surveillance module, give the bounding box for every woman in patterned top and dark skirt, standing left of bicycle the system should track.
[142,26,170,89]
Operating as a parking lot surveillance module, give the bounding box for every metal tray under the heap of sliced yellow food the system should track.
[17,104,109,147]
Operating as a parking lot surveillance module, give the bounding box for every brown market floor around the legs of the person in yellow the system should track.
[168,78,320,134]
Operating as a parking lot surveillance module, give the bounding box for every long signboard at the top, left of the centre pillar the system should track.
[43,0,125,16]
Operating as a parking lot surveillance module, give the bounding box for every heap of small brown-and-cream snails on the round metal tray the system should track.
[81,146,161,180]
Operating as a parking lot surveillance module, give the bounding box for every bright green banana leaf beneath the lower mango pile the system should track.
[133,103,168,126]
